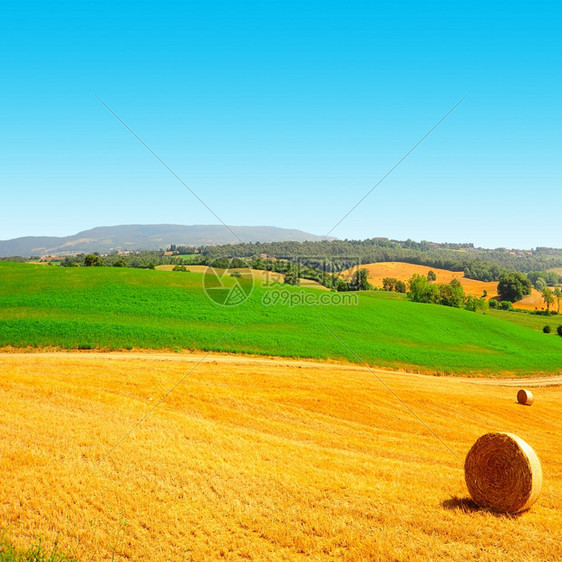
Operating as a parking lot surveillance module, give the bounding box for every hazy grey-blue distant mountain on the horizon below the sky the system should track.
[0,224,333,257]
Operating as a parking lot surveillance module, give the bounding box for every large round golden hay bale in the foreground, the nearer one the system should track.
[464,433,542,513]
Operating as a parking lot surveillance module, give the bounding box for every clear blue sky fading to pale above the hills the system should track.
[0,0,562,248]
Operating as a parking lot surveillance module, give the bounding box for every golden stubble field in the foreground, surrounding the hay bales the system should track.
[0,353,562,560]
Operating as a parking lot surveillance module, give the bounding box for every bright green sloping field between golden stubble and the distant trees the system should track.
[0,262,562,374]
